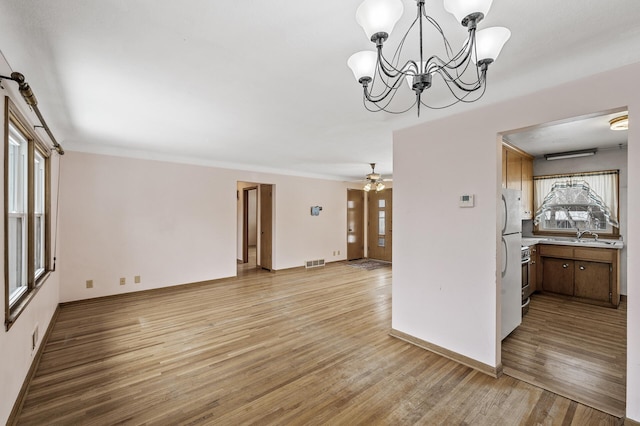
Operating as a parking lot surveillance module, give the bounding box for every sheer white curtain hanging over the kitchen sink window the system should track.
[533,171,618,221]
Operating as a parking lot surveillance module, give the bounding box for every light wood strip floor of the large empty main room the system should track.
[19,262,621,425]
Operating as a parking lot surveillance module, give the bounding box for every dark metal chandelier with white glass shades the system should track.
[347,0,511,116]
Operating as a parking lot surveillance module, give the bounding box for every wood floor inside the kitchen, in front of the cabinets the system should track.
[502,294,627,417]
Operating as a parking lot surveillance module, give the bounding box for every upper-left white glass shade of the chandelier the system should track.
[356,0,404,40]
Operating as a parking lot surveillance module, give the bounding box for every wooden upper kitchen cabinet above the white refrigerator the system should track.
[502,142,533,219]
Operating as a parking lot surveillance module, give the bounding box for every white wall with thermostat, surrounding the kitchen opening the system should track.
[392,64,640,421]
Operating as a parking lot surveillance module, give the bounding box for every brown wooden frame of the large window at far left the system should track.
[4,96,52,330]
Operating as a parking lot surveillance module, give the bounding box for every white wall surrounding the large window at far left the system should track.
[0,65,60,424]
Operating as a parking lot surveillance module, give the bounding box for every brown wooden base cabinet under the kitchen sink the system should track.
[538,244,620,307]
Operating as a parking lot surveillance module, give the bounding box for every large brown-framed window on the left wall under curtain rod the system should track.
[4,98,49,328]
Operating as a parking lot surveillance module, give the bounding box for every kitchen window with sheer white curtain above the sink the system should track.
[534,170,619,235]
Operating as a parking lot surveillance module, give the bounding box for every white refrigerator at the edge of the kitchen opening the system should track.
[500,189,522,339]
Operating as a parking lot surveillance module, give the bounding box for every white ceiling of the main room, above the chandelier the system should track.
[0,0,640,180]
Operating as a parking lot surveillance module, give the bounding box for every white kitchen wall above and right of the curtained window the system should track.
[533,147,629,294]
